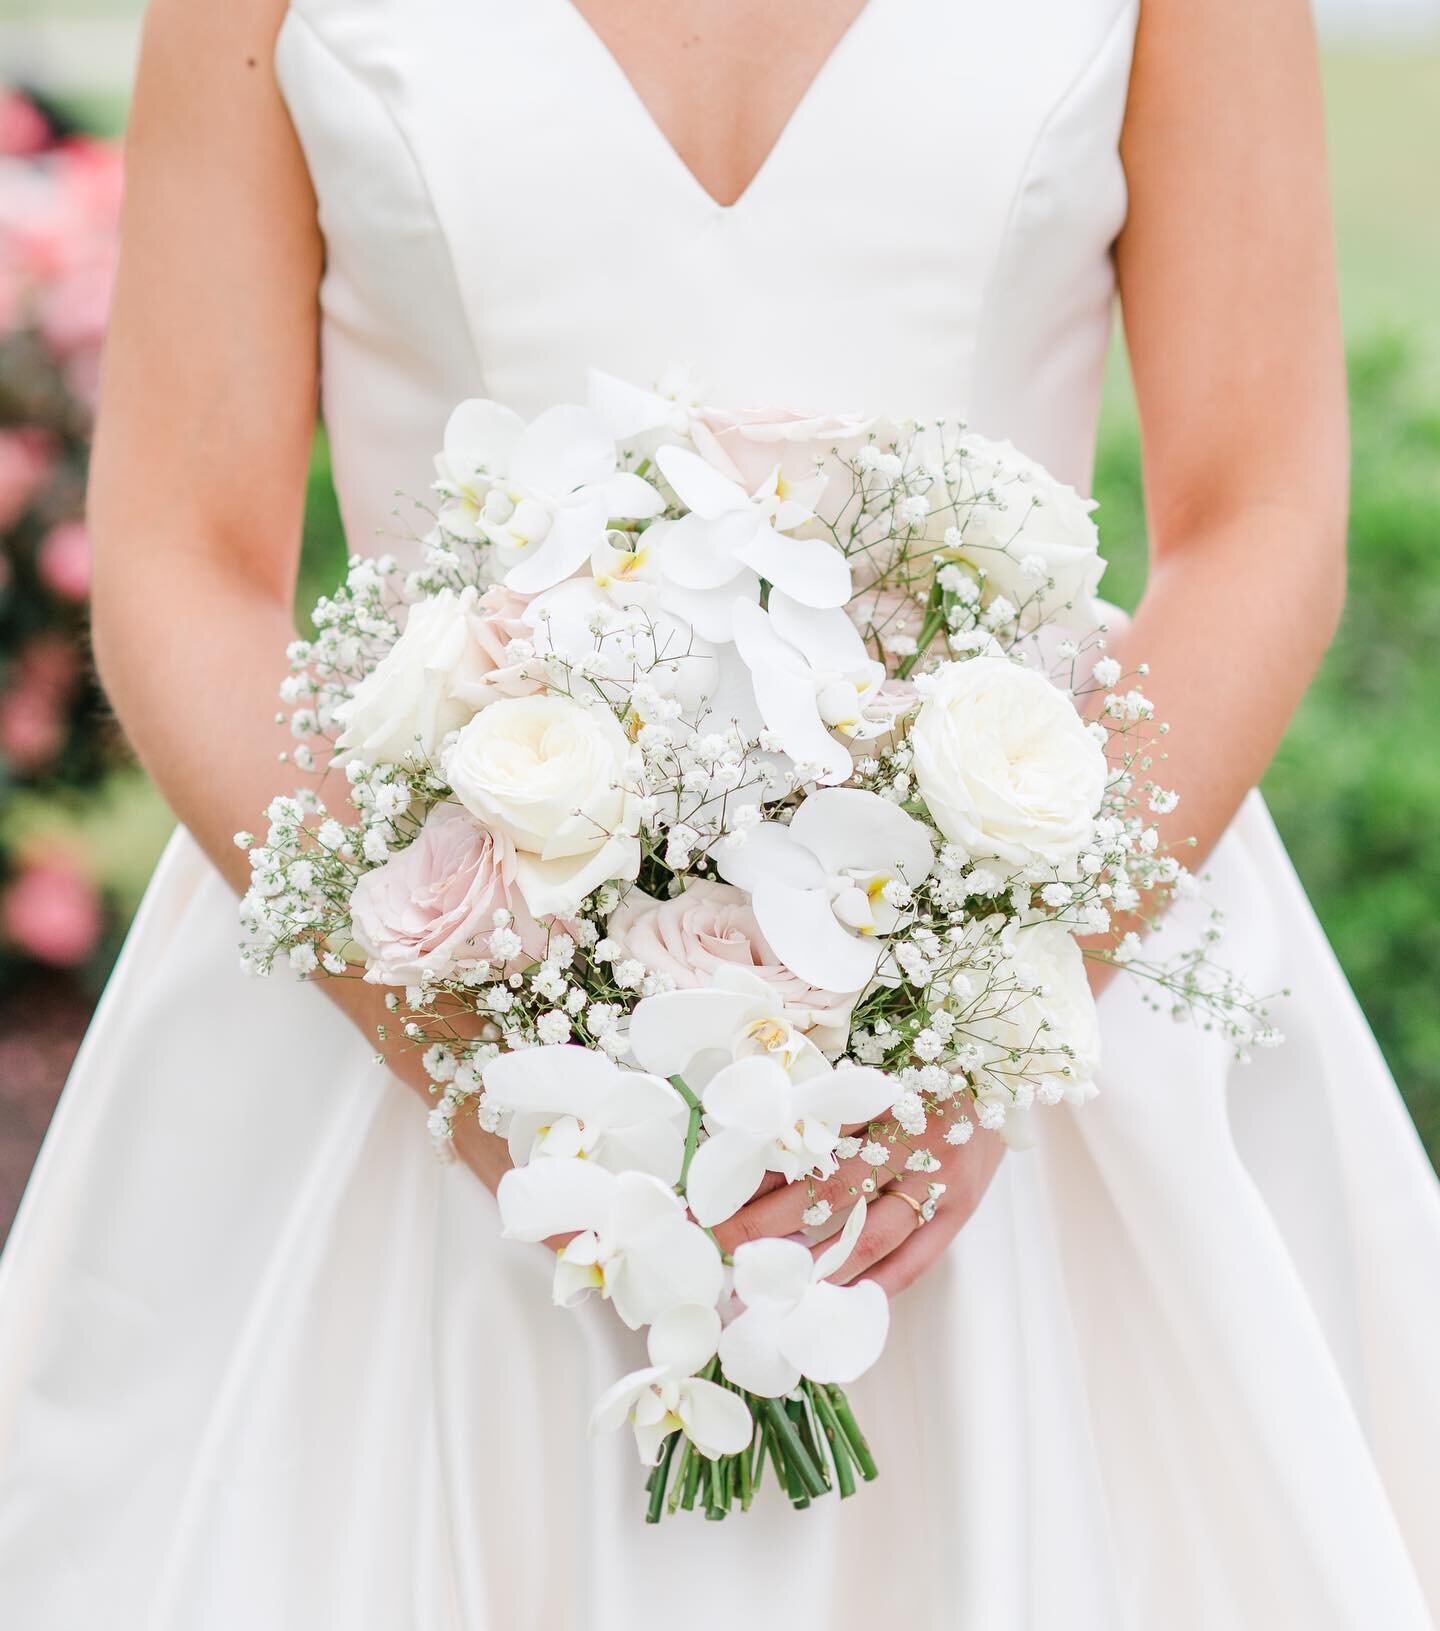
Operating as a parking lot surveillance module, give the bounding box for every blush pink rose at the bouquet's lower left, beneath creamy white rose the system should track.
[351,804,546,985]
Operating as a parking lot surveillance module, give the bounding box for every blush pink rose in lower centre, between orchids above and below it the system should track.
[605,881,859,1054]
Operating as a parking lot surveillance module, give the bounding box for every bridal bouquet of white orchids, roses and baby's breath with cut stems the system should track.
[236,366,1274,1522]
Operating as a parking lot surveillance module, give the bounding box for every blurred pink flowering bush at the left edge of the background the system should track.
[0,98,121,975]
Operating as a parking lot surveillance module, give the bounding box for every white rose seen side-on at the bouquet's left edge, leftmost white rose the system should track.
[336,589,494,765]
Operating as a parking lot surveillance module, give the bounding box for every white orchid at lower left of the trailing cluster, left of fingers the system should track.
[496,1156,724,1331]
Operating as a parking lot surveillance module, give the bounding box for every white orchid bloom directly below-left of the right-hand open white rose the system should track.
[716,788,934,992]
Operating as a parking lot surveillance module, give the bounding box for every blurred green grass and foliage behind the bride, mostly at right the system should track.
[67,55,1440,1163]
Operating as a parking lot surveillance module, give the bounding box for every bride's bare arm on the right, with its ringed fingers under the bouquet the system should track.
[719,0,1349,1292]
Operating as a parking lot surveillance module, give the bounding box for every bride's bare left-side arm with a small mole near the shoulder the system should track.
[90,0,507,1182]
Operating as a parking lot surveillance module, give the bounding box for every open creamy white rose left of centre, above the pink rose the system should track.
[445,696,639,917]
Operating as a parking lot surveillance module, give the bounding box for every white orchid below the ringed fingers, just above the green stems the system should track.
[719,1200,890,1399]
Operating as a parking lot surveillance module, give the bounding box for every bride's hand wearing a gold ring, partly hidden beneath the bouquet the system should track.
[716,1127,1005,1297]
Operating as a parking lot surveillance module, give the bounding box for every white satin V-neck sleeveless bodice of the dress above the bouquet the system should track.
[277,0,1138,546]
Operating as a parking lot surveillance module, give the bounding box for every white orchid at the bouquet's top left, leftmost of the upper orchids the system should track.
[435,400,664,595]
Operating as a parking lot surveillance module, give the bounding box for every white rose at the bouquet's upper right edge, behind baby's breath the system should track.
[959,431,1106,633]
